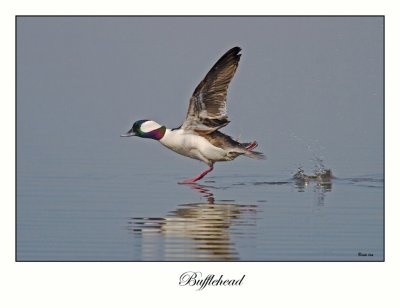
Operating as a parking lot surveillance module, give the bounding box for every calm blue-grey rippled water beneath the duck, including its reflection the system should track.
[17,151,383,261]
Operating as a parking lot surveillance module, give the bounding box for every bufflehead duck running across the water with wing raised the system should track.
[121,47,264,183]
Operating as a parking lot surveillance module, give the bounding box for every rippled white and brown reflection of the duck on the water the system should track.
[129,184,257,261]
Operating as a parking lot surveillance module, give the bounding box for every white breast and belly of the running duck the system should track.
[160,129,227,164]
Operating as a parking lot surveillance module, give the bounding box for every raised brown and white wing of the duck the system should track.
[182,47,241,133]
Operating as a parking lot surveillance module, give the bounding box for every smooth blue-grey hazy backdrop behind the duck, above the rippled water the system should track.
[17,17,383,175]
